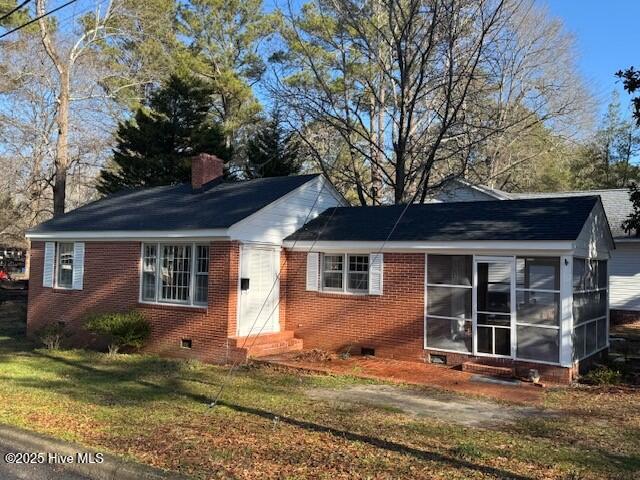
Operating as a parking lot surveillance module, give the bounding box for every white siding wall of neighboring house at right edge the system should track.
[609,242,640,311]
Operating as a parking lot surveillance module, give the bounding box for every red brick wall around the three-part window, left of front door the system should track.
[27,242,239,362]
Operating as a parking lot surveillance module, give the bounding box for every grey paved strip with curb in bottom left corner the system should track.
[0,424,186,480]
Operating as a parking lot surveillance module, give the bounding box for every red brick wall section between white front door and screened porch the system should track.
[281,251,424,360]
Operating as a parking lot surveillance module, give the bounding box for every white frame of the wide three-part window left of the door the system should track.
[138,242,211,309]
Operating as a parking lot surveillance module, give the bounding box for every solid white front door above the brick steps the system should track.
[238,245,280,337]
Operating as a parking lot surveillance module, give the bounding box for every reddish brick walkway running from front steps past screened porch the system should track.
[254,354,543,406]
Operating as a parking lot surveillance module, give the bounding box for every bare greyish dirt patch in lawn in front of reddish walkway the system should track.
[307,385,553,427]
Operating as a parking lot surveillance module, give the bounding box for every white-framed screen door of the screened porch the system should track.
[474,257,515,357]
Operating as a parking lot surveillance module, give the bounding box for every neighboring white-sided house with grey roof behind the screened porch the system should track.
[433,180,640,323]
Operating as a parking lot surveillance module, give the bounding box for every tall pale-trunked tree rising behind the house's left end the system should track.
[31,0,173,216]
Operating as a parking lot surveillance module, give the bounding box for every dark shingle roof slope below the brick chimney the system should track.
[30,174,318,233]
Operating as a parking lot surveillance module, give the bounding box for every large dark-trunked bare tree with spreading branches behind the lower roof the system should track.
[272,0,592,204]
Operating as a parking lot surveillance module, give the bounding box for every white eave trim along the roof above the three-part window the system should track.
[26,228,229,240]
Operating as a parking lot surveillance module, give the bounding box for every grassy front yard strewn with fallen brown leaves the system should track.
[0,294,640,479]
